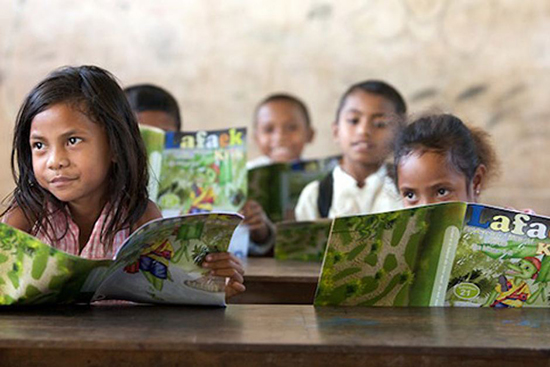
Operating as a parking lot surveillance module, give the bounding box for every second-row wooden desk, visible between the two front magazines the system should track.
[231,258,321,305]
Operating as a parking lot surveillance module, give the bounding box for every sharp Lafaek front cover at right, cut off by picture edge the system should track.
[445,204,550,308]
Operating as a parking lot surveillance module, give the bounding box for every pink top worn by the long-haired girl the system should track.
[36,206,130,259]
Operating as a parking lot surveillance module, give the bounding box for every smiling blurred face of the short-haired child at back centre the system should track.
[254,101,313,162]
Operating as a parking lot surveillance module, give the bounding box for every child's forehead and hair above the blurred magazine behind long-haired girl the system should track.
[124,84,181,131]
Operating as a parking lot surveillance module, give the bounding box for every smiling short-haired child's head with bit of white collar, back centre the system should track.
[247,94,315,169]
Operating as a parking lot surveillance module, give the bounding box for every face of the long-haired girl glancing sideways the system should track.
[29,103,113,205]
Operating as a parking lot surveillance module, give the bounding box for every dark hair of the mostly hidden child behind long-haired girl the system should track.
[124,84,181,131]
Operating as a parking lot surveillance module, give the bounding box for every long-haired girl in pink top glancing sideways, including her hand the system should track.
[2,66,244,297]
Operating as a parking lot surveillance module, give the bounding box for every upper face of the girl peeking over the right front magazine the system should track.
[397,151,475,207]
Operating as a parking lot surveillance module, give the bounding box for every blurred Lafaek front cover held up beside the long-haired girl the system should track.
[157,128,247,217]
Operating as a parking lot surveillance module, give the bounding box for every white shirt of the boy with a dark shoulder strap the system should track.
[295,165,403,221]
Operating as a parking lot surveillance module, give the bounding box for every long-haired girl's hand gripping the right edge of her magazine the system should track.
[202,252,246,299]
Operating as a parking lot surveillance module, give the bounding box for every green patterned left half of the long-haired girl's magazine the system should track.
[0,223,112,305]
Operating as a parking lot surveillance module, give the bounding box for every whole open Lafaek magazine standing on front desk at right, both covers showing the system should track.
[315,202,550,308]
